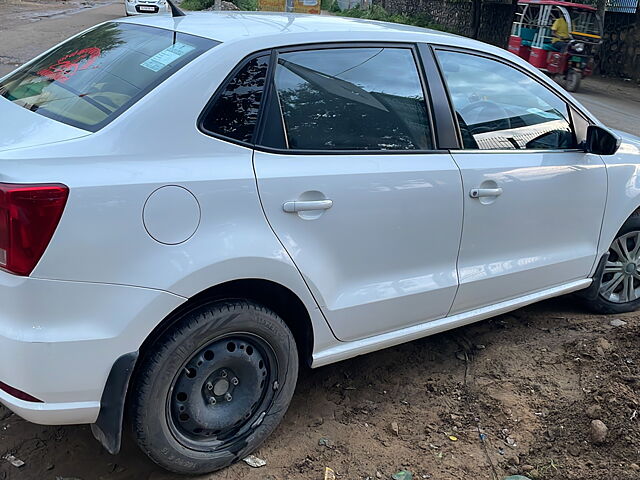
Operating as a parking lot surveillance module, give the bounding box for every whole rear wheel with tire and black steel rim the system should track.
[128,301,298,475]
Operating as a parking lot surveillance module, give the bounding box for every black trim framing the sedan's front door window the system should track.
[429,44,596,154]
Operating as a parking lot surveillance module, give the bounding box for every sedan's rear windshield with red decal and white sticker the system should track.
[0,23,217,132]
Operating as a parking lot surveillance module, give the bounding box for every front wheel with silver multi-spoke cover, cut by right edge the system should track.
[585,215,640,314]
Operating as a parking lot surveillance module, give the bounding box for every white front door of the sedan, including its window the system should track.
[436,49,607,314]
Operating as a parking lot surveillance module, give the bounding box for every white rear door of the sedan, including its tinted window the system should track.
[254,44,462,341]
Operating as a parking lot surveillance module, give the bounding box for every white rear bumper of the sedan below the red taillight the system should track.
[0,272,185,425]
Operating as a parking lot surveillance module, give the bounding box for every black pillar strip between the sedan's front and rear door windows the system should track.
[418,43,461,150]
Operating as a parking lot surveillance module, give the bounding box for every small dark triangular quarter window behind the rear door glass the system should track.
[202,55,269,142]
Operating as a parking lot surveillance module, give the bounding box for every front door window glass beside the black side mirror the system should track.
[438,51,576,150]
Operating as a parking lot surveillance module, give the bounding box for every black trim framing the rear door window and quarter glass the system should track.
[196,41,448,155]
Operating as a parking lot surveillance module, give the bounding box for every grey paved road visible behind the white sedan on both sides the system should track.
[0,0,640,136]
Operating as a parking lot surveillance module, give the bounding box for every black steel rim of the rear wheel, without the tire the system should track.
[166,332,278,452]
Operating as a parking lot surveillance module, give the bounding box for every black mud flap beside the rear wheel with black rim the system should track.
[91,352,138,455]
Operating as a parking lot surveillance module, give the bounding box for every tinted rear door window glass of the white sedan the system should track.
[275,47,431,150]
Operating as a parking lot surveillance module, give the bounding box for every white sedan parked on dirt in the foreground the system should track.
[0,5,640,474]
